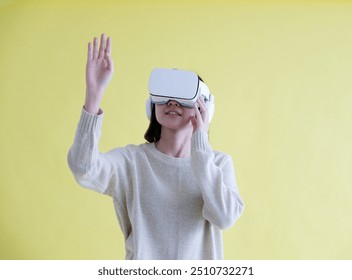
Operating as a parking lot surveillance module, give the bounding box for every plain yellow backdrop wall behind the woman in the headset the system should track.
[0,0,352,259]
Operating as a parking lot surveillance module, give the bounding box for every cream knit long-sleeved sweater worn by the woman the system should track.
[68,109,244,259]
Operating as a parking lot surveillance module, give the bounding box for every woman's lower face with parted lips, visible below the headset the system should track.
[155,100,195,130]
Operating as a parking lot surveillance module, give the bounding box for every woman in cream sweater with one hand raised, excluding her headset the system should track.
[68,34,244,259]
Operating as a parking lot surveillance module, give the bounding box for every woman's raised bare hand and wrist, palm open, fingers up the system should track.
[84,34,114,114]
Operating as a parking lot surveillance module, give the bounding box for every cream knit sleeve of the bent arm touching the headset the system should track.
[191,131,244,229]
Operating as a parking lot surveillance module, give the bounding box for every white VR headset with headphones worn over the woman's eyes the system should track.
[146,68,214,122]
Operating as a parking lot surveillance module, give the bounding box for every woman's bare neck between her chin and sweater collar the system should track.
[155,128,192,158]
